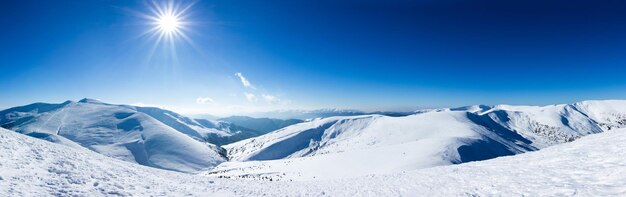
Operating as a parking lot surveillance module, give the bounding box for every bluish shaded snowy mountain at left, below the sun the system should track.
[0,99,228,172]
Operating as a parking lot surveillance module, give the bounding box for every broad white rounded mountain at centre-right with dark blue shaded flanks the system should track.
[216,111,536,179]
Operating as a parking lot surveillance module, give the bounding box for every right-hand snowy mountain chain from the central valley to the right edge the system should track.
[208,101,626,179]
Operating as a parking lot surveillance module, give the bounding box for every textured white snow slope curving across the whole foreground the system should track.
[0,129,626,196]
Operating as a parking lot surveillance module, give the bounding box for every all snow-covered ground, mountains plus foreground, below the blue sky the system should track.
[0,99,626,196]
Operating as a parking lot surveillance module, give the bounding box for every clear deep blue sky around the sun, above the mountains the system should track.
[0,0,626,115]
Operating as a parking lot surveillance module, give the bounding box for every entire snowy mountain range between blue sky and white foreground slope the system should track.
[0,99,626,179]
